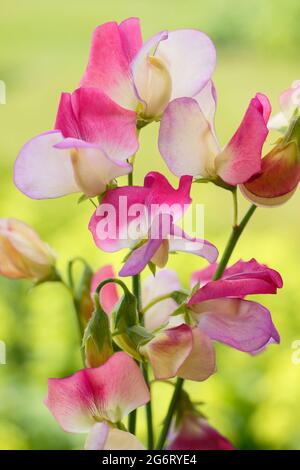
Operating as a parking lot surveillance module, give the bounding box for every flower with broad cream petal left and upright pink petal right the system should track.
[159,89,271,186]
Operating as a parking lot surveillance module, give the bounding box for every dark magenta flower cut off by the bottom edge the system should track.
[167,413,234,450]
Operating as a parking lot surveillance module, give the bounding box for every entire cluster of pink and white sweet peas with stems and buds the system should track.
[0,18,300,450]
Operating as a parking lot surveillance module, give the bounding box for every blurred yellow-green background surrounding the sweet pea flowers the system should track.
[0,0,300,449]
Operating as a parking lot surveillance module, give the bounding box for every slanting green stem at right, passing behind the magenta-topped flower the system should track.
[157,204,257,450]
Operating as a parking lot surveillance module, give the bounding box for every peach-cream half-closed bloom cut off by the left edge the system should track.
[0,218,56,282]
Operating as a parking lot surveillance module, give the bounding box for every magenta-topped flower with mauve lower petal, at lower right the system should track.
[187,259,282,354]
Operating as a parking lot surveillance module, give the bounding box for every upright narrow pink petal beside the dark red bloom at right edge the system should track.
[216,93,271,185]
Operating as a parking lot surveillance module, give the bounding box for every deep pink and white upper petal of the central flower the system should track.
[89,172,192,252]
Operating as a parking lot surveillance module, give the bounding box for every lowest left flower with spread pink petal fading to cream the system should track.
[45,352,150,450]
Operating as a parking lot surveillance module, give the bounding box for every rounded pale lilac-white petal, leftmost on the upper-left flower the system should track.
[14,131,80,199]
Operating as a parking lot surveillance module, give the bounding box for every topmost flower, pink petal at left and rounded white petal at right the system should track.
[81,18,216,126]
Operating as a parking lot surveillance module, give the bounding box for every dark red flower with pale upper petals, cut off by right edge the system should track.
[241,81,300,207]
